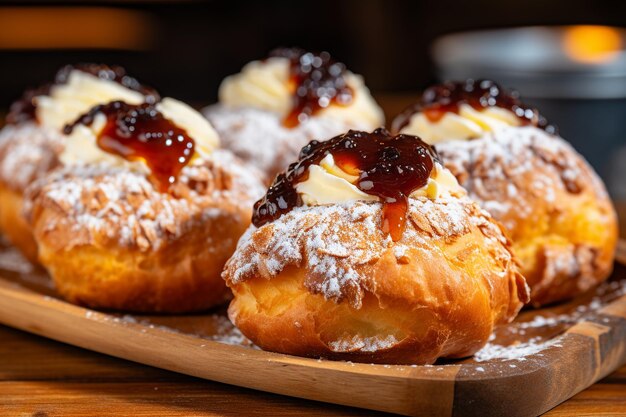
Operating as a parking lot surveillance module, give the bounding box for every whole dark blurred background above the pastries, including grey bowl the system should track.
[0,0,626,199]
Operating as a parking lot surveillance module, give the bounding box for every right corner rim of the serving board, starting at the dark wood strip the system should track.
[446,296,626,416]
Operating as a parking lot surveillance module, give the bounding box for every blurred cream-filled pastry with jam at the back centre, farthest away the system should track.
[205,48,384,179]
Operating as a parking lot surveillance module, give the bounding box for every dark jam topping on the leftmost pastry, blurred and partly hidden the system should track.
[6,64,161,124]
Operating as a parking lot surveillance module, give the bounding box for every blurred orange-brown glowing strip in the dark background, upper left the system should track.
[0,7,155,50]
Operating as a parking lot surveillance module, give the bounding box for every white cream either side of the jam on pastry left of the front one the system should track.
[60,97,219,173]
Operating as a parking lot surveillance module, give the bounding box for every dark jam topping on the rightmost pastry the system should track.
[392,79,557,134]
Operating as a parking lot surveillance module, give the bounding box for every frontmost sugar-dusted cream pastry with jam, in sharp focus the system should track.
[222,129,528,364]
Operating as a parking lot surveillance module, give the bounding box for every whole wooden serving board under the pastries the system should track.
[0,242,626,416]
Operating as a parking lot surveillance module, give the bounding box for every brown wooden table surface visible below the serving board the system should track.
[0,326,626,417]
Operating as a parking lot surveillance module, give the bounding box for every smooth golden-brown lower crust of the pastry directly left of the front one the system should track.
[35,208,241,313]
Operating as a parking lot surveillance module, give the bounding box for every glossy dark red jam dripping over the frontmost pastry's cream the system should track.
[252,128,438,241]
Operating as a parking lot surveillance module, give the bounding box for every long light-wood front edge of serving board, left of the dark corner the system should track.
[0,278,461,415]
